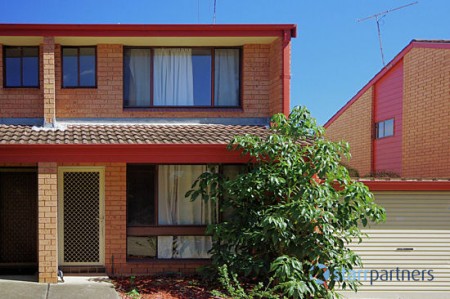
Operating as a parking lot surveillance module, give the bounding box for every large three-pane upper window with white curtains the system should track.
[124,48,240,107]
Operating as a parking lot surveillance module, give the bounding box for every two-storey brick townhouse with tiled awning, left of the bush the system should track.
[0,24,296,283]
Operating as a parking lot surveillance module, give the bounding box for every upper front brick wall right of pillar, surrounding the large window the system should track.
[55,45,281,118]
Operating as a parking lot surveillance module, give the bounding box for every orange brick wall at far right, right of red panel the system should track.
[403,48,450,178]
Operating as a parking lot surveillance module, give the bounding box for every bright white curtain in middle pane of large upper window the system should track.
[153,48,194,106]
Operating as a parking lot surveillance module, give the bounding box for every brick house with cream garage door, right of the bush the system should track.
[325,40,450,298]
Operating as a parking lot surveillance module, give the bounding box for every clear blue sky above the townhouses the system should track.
[0,0,450,124]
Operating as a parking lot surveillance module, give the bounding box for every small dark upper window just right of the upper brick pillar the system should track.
[62,47,97,88]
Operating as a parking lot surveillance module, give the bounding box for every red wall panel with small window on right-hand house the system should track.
[373,60,403,175]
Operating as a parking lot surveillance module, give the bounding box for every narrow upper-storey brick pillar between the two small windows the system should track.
[42,36,55,127]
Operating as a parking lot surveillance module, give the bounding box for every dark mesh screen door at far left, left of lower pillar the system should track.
[0,172,37,264]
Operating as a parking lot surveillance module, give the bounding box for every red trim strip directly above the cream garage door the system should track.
[361,181,450,191]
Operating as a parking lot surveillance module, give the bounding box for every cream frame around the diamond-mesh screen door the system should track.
[58,166,105,266]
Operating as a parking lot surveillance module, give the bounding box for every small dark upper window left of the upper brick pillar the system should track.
[3,47,39,87]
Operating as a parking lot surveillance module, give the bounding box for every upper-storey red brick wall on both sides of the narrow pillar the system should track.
[0,39,282,118]
